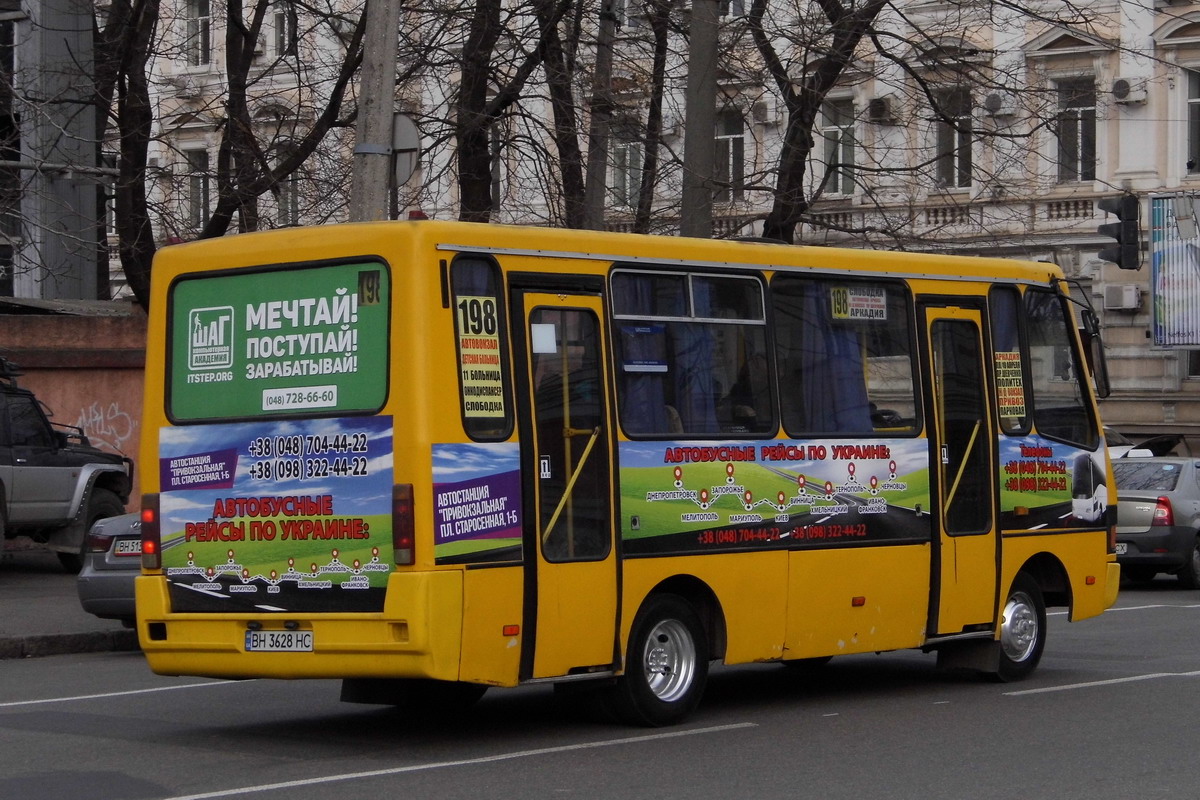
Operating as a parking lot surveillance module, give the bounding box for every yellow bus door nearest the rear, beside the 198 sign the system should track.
[517,291,617,679]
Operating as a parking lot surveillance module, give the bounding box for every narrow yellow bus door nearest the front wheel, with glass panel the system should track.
[925,306,1000,636]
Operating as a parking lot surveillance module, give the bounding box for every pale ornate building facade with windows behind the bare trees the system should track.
[138,0,1200,446]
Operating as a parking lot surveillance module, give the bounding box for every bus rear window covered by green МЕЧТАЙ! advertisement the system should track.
[167,261,391,422]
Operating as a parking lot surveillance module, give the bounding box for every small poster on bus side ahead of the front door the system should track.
[1000,435,1109,530]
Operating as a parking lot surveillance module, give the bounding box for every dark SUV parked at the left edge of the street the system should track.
[0,356,133,572]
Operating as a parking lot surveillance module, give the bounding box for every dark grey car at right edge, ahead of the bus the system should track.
[1112,457,1200,589]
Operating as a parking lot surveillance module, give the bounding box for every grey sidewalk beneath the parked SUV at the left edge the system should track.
[0,551,138,658]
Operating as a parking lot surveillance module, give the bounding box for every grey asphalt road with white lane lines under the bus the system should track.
[0,579,1200,800]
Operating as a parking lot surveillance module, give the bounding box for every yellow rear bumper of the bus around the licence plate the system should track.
[136,571,462,680]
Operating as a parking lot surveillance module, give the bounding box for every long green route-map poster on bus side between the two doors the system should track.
[620,439,931,555]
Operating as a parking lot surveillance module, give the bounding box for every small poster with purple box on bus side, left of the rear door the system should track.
[433,441,522,564]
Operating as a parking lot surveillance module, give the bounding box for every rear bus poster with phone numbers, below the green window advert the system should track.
[158,416,394,612]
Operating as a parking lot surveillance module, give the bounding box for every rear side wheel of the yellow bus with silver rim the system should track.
[610,595,708,727]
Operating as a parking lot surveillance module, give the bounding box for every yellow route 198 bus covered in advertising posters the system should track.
[137,222,1118,724]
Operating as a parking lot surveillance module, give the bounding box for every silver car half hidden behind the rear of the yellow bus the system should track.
[77,513,142,627]
